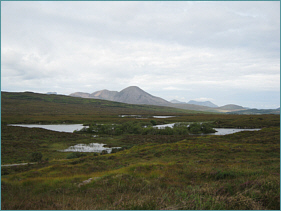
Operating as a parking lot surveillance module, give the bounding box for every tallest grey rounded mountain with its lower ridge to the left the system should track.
[70,86,170,106]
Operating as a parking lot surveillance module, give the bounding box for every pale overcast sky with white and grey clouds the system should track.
[1,1,280,109]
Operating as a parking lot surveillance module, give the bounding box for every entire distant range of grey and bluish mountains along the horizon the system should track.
[70,86,278,113]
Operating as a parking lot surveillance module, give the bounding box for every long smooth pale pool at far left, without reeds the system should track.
[8,124,88,133]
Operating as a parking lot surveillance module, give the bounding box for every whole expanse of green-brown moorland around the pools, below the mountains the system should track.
[1,92,280,210]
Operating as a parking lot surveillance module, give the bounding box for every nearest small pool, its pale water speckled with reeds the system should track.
[60,143,121,153]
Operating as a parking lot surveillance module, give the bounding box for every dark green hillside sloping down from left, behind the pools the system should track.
[1,92,205,123]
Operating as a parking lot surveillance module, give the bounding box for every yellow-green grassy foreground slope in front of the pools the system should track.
[1,127,280,210]
